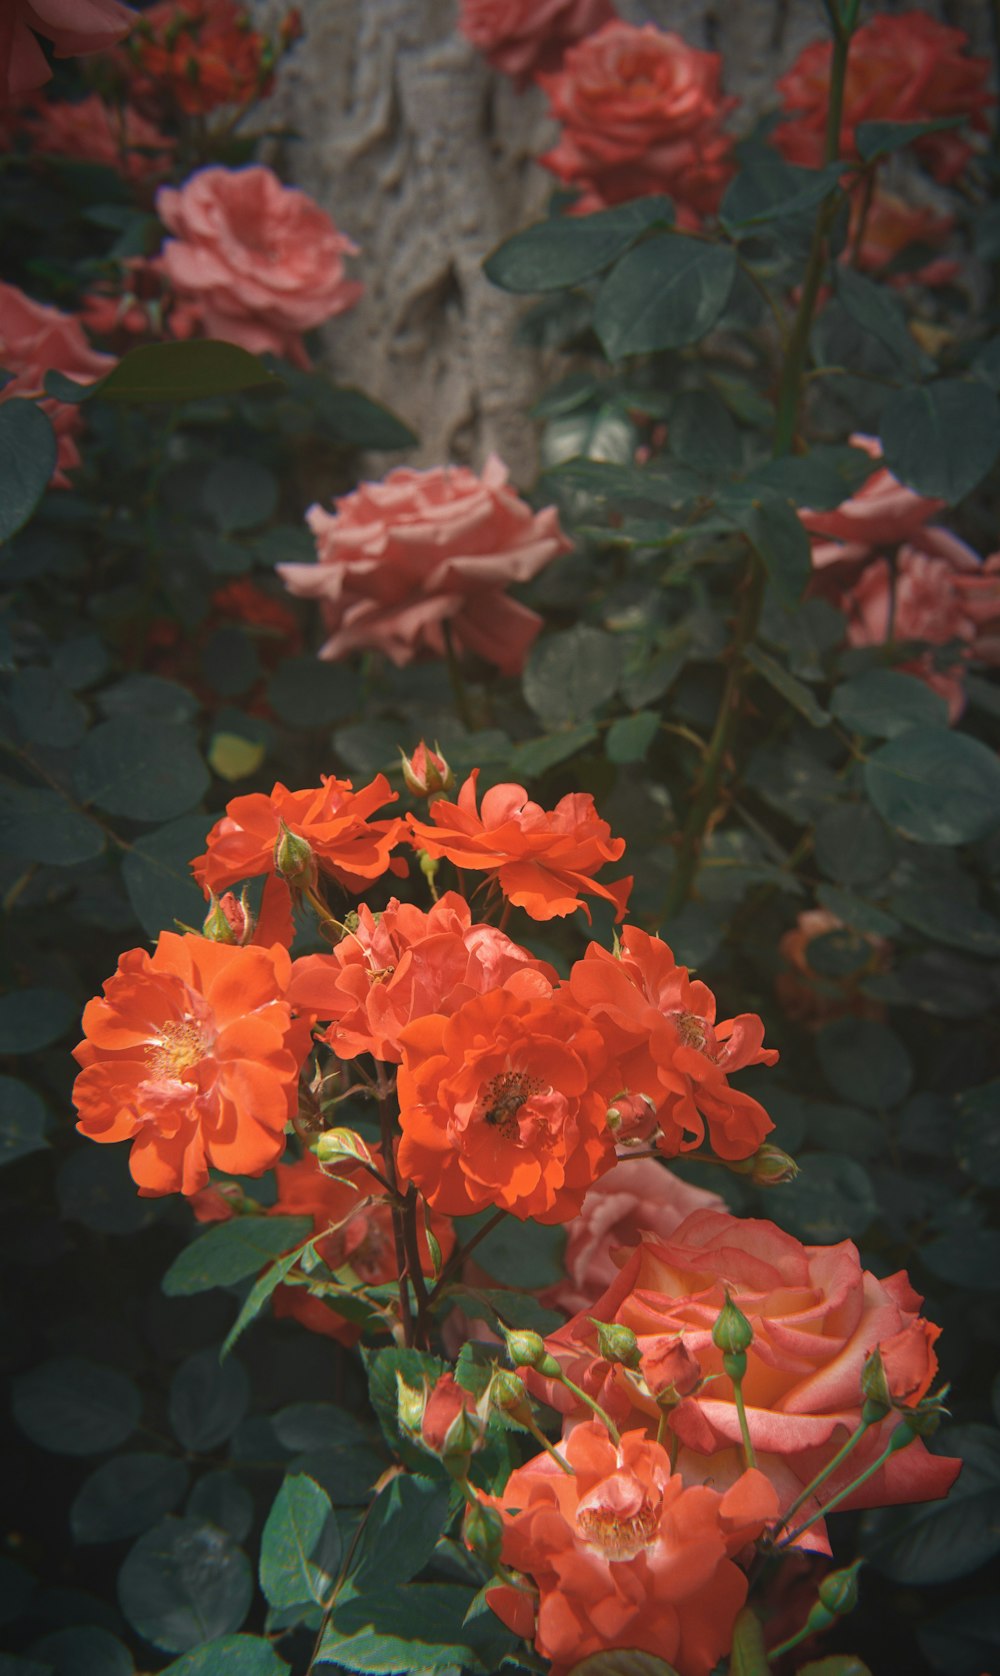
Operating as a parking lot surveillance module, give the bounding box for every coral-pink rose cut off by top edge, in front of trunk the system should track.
[459,0,615,87]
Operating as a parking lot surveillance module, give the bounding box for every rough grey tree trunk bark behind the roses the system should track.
[260,0,995,484]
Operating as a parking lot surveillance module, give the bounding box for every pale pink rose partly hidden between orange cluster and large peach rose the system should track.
[539,1158,722,1316]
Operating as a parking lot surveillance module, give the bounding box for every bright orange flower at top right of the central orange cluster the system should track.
[409,768,631,920]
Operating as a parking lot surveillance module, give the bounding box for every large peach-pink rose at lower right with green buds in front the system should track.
[526,1210,960,1552]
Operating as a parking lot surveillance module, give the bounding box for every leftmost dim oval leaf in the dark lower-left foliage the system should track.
[12,1356,142,1455]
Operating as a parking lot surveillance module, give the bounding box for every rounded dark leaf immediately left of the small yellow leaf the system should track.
[74,716,209,823]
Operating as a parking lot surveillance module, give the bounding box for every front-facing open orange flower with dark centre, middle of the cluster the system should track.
[397,977,615,1222]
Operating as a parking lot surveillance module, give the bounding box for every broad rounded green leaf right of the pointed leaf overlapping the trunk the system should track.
[593,233,737,360]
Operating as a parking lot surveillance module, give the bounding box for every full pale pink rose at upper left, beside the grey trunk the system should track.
[156,163,362,367]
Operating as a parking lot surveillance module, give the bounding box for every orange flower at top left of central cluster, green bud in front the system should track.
[191,774,405,893]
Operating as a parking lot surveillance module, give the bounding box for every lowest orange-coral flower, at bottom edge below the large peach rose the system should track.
[481,1420,777,1676]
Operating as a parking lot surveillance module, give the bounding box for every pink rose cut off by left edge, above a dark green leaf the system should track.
[0,283,114,489]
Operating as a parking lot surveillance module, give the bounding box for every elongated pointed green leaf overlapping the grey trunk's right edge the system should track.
[482,196,673,292]
